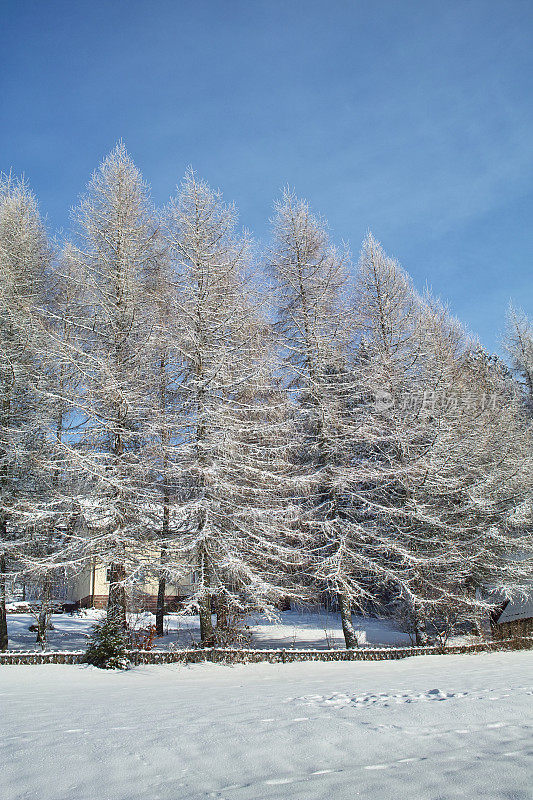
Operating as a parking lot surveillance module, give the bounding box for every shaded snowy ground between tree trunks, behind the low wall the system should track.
[7,610,409,650]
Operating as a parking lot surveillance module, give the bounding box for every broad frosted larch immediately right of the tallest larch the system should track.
[160,171,304,645]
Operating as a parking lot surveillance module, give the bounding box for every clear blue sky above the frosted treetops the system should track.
[0,0,533,349]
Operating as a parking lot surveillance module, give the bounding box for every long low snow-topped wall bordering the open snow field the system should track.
[0,636,533,665]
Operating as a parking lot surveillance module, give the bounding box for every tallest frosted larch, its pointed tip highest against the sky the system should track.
[61,143,161,623]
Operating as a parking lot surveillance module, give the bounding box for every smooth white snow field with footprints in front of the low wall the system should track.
[0,652,533,800]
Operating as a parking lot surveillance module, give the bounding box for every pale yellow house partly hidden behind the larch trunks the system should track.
[67,559,193,611]
